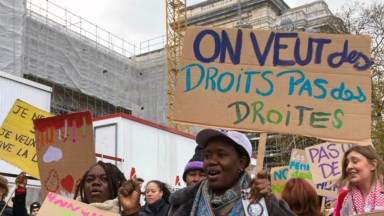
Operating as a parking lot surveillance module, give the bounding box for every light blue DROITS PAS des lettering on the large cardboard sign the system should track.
[180,64,367,103]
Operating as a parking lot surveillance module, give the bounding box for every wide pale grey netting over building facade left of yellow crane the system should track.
[23,12,167,125]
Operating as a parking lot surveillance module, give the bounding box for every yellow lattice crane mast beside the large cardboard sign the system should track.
[165,0,190,133]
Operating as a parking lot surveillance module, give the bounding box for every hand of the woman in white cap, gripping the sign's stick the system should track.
[248,169,272,212]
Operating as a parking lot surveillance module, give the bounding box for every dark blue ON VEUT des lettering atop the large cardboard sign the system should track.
[193,29,371,71]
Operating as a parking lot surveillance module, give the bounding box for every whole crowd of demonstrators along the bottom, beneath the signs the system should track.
[4,129,384,216]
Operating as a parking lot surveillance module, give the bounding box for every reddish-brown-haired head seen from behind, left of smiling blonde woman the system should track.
[281,178,325,216]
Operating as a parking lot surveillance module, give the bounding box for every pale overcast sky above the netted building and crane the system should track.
[28,0,380,53]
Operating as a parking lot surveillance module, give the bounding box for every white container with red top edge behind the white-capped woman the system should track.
[93,113,197,189]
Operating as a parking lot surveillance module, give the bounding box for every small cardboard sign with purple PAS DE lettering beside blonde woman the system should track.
[305,142,353,183]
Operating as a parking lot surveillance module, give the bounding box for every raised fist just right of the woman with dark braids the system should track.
[118,178,141,214]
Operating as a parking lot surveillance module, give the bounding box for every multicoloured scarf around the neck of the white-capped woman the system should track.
[191,172,251,216]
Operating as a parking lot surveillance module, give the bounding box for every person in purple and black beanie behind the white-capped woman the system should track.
[183,146,207,186]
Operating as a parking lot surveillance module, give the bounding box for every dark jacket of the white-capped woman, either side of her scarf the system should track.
[168,181,296,216]
